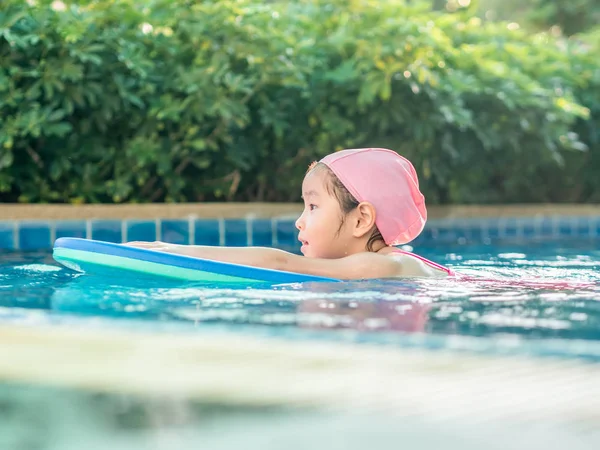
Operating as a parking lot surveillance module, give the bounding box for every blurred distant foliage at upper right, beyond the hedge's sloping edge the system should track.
[468,0,600,202]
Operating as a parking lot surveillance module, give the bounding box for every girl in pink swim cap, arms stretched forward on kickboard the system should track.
[127,148,452,280]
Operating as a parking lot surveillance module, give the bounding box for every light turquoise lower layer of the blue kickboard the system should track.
[53,247,259,283]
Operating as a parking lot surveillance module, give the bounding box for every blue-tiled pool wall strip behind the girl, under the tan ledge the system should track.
[0,214,600,252]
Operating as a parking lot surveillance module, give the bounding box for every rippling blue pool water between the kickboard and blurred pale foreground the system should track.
[0,240,600,353]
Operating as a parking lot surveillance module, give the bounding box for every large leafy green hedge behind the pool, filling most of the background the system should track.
[0,0,600,203]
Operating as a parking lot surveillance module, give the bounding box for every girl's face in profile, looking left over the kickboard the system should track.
[296,170,354,258]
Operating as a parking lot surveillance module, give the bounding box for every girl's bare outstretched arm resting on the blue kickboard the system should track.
[125,242,402,280]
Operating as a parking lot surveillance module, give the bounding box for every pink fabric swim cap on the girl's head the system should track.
[320,148,427,245]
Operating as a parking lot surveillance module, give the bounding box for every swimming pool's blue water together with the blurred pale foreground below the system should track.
[0,239,600,449]
